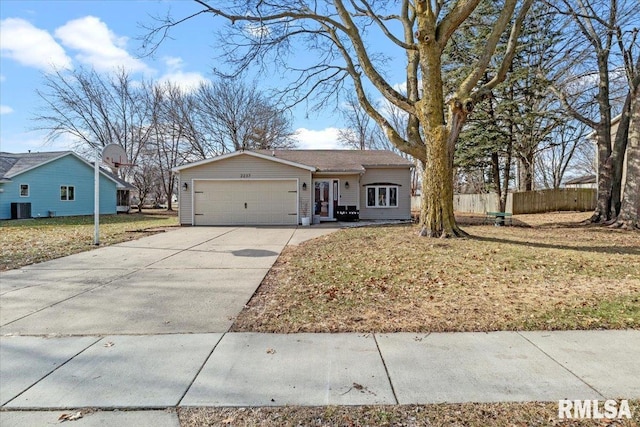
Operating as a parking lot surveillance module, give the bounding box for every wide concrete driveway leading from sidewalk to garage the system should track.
[0,227,335,335]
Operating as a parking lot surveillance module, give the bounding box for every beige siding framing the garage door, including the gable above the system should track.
[179,155,312,225]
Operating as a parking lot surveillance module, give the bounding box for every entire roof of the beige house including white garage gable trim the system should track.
[173,150,413,173]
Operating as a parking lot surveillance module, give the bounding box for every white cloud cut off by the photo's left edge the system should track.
[0,18,71,71]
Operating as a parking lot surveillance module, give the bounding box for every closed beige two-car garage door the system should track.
[194,180,298,225]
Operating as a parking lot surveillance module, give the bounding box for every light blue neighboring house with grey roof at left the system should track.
[0,151,134,219]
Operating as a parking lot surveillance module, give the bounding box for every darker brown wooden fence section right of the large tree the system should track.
[512,188,597,214]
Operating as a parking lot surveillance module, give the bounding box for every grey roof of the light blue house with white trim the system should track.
[0,151,134,189]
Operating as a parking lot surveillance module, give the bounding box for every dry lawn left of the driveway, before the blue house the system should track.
[0,211,178,271]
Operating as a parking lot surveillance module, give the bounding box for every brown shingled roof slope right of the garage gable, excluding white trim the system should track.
[256,150,413,172]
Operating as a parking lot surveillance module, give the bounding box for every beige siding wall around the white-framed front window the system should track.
[360,168,411,220]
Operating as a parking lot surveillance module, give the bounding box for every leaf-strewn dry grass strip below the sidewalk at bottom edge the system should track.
[178,401,640,427]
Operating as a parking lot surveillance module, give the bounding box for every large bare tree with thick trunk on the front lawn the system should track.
[144,0,533,237]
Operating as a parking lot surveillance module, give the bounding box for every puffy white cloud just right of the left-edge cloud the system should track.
[54,16,149,72]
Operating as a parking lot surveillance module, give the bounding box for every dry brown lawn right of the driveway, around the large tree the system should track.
[232,214,640,333]
